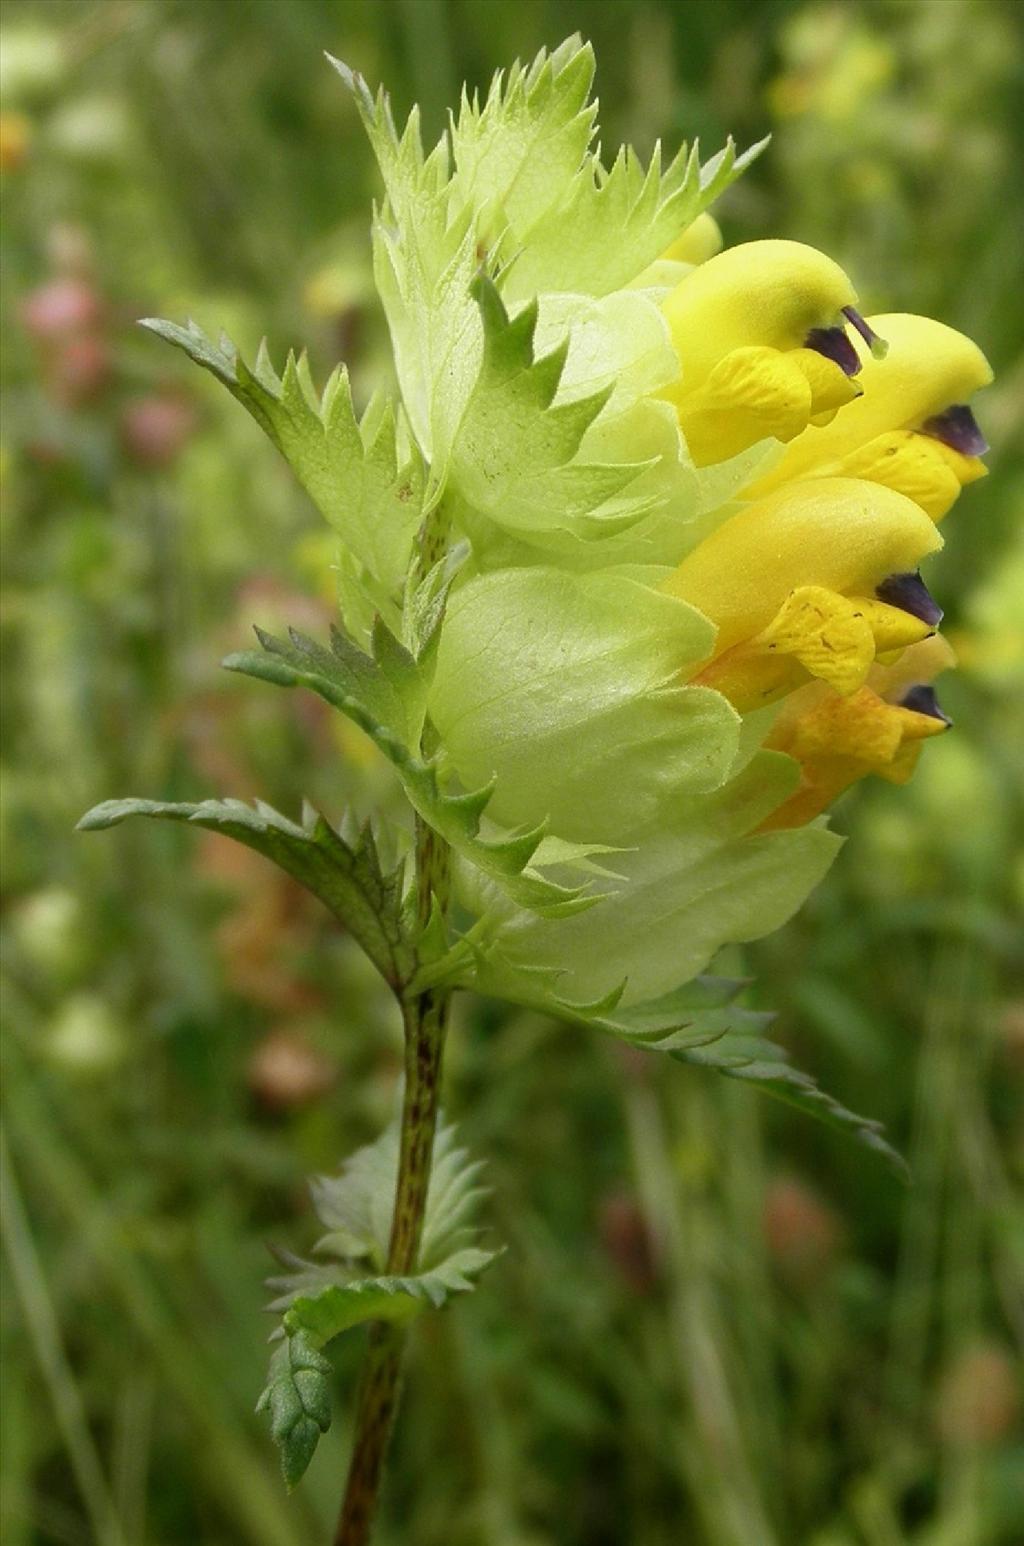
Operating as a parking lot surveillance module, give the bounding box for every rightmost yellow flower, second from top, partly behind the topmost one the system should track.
[749,312,992,521]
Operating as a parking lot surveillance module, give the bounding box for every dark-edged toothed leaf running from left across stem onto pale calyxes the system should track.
[224,631,594,917]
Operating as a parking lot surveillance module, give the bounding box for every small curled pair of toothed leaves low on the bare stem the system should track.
[257,1119,500,1487]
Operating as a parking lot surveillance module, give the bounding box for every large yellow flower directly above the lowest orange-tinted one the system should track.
[665,478,942,713]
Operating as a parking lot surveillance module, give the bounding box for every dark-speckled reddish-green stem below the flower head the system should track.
[334,822,452,1546]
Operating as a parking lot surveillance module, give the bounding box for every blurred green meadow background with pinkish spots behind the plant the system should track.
[0,0,1024,1546]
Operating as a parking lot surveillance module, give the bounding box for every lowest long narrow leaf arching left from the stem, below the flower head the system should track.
[79,799,415,986]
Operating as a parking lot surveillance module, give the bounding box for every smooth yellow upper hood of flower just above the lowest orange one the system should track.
[665,478,942,656]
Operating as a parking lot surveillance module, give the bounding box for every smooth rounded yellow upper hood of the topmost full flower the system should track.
[662,241,857,393]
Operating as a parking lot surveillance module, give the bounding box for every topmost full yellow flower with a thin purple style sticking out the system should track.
[662,241,884,467]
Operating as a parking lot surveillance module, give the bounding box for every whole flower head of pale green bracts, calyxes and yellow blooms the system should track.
[110,39,990,1014]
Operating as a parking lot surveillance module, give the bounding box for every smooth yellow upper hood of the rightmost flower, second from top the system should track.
[749,312,992,497]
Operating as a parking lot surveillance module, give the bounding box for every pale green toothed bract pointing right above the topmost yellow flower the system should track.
[504,139,767,300]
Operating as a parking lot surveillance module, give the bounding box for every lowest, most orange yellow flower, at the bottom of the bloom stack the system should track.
[761,637,953,830]
